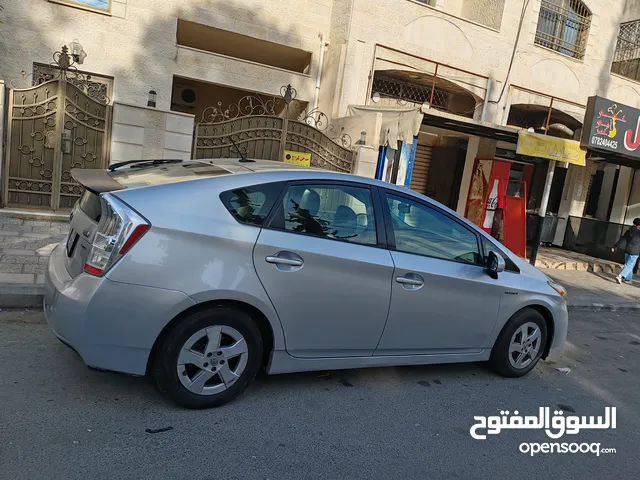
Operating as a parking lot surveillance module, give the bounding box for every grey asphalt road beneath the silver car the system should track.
[0,312,640,480]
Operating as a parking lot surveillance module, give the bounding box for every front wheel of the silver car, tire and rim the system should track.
[489,308,547,378]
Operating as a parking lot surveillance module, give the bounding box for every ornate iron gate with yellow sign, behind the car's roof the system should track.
[193,85,355,173]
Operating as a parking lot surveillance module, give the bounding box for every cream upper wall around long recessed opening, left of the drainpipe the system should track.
[0,0,332,109]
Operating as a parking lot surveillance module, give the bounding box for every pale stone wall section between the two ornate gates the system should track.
[111,103,194,163]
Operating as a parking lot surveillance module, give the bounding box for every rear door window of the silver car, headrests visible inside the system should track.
[271,185,378,245]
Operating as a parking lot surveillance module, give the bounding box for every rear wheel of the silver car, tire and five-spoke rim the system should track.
[153,306,263,409]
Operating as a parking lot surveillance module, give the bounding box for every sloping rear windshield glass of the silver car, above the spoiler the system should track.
[110,162,231,188]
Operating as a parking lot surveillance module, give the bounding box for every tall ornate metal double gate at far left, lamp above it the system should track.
[2,47,111,210]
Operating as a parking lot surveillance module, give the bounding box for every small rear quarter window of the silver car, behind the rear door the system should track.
[220,183,284,226]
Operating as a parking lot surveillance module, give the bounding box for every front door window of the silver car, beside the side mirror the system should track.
[387,195,484,265]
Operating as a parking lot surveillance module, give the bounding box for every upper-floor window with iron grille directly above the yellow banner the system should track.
[535,0,591,60]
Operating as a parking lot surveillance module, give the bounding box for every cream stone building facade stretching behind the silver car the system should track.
[0,0,640,258]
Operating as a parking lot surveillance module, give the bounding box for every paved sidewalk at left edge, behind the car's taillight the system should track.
[0,213,69,308]
